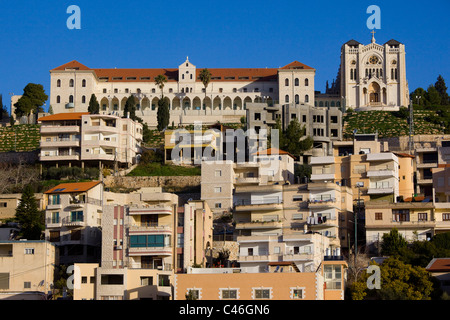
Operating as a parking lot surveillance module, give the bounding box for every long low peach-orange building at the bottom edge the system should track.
[174,261,346,301]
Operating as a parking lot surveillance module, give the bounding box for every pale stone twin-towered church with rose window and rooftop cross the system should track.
[339,33,409,111]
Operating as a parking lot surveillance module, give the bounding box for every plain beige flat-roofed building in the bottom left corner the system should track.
[0,240,58,300]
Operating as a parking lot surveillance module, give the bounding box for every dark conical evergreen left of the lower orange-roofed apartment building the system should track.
[16,185,45,240]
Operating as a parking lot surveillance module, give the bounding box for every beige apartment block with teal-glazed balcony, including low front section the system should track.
[71,188,212,300]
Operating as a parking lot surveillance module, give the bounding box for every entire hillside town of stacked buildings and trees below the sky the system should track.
[0,32,450,300]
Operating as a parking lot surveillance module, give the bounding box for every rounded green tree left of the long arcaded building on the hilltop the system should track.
[14,83,48,118]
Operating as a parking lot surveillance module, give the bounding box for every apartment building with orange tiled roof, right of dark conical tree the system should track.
[44,181,103,265]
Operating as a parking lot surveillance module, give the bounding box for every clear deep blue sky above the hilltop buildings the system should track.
[0,0,450,110]
